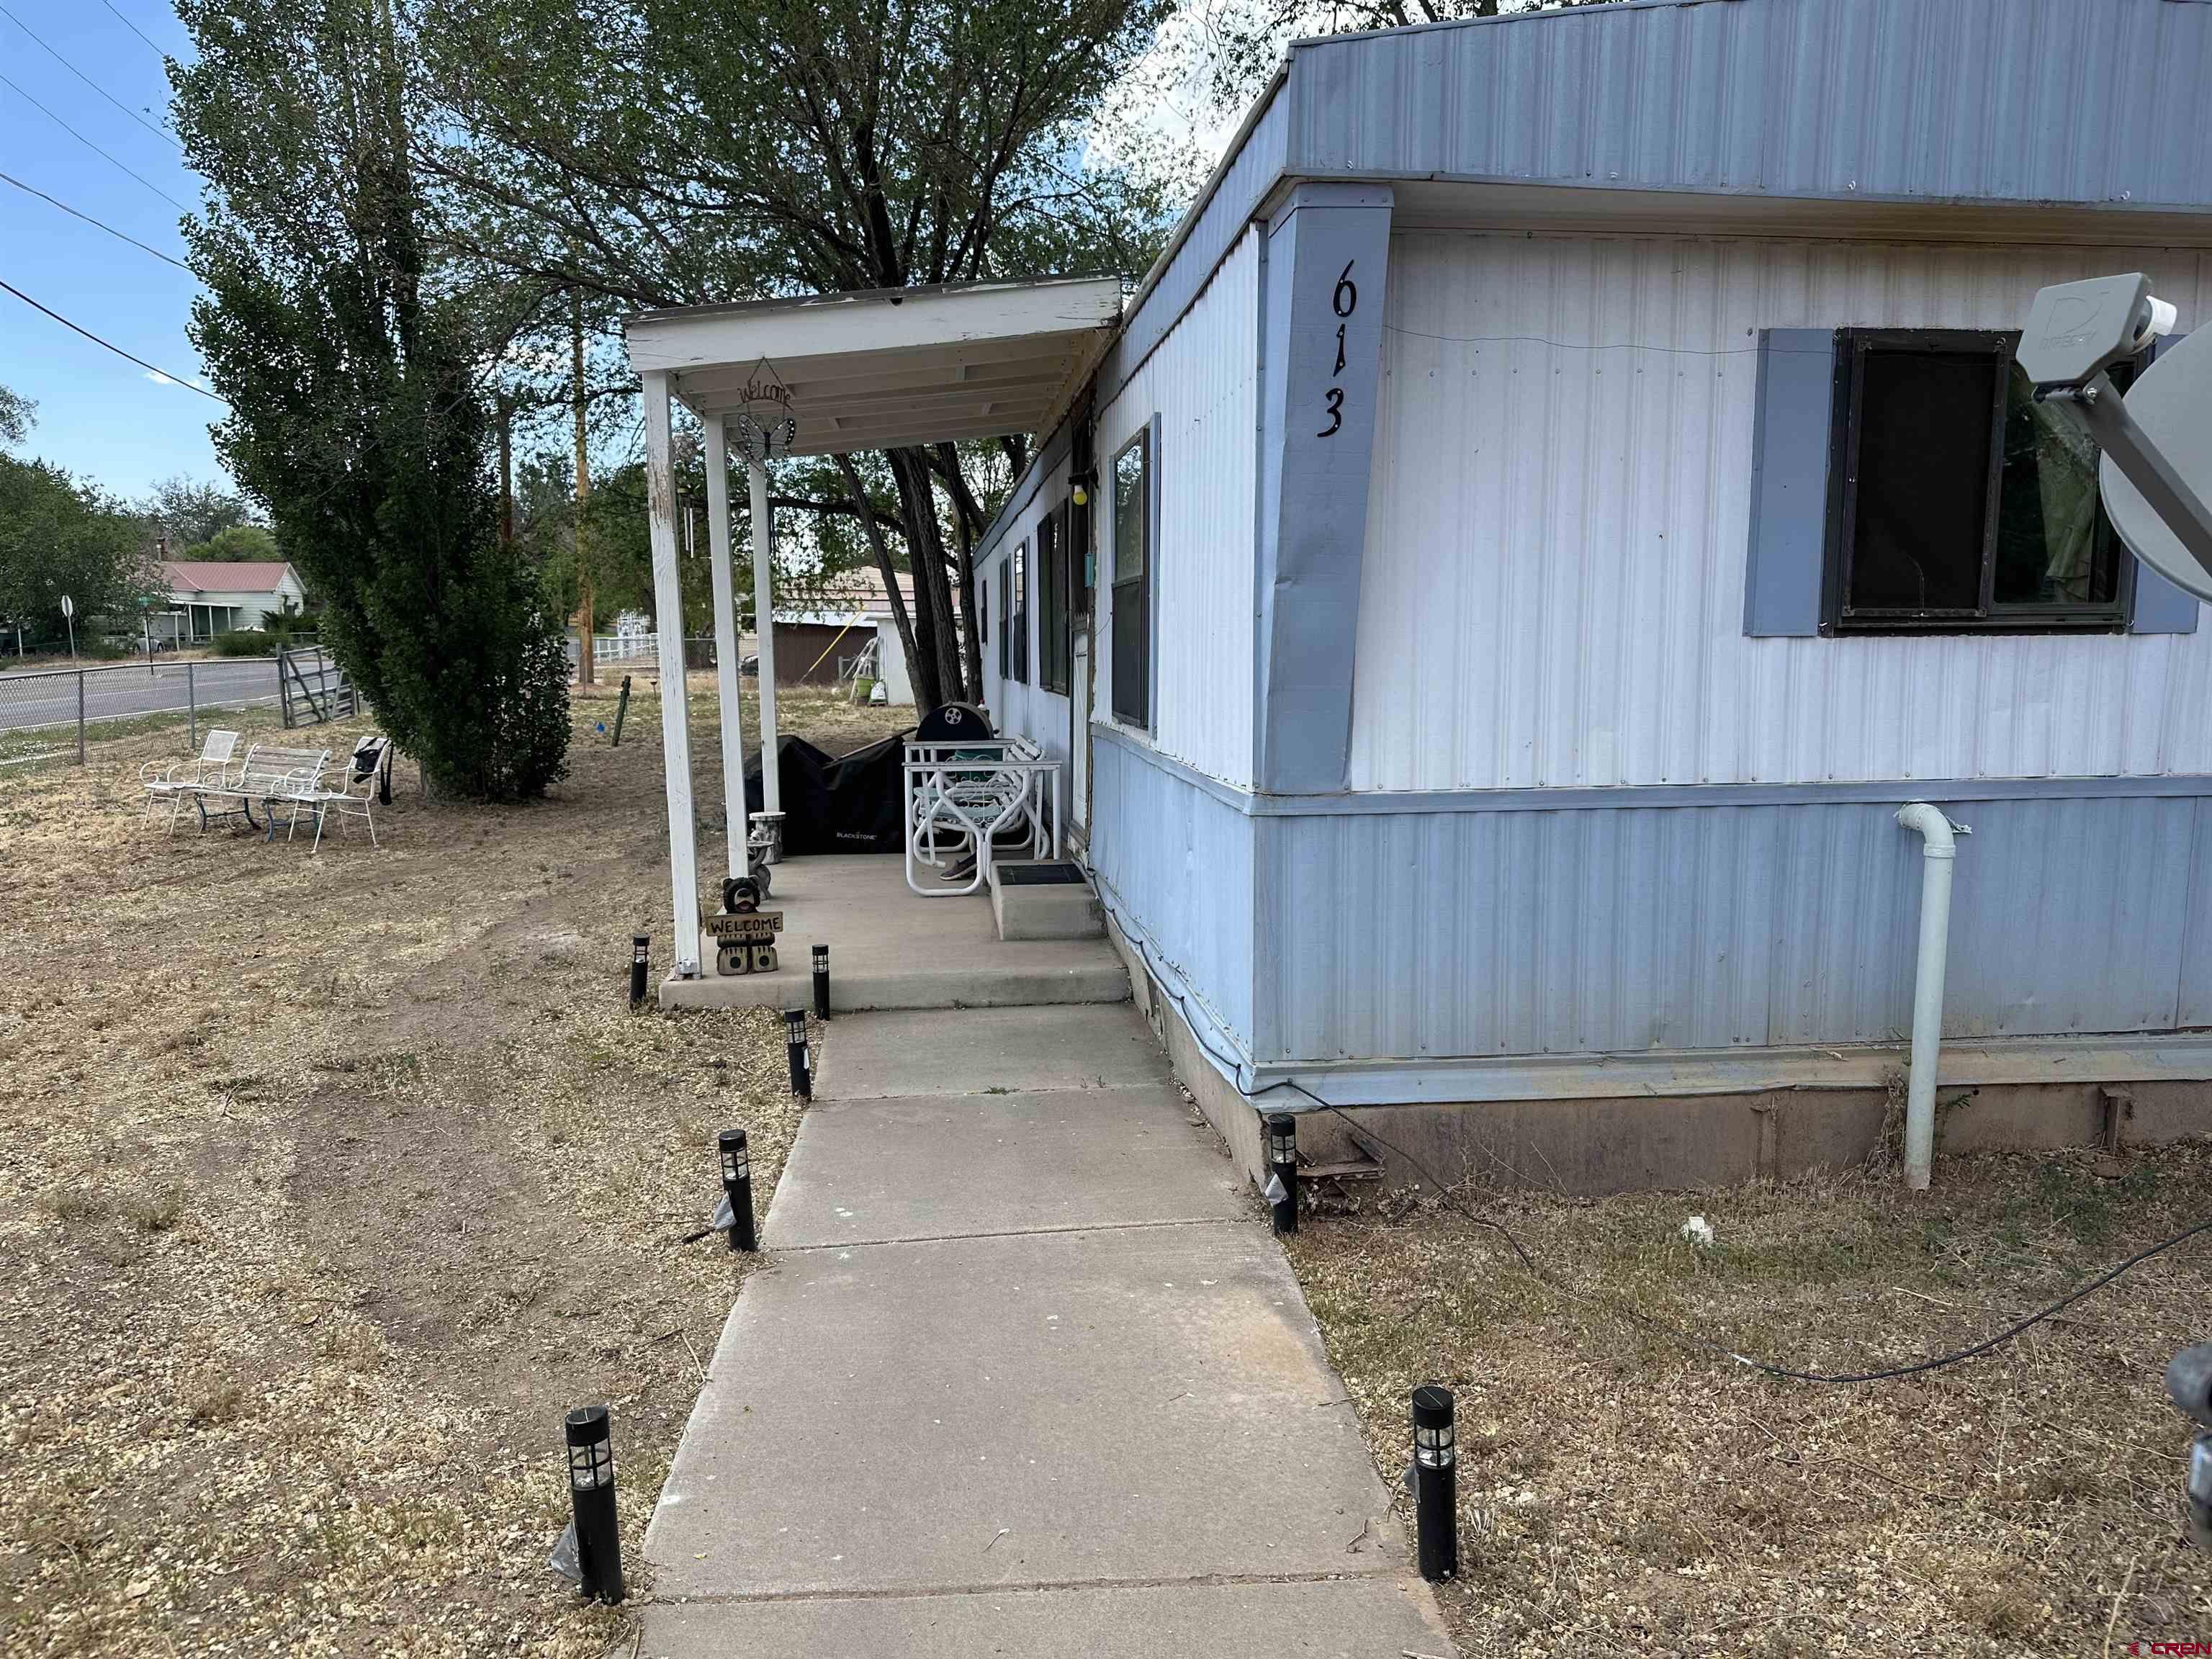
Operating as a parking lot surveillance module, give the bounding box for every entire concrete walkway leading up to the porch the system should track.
[644,1004,1451,1659]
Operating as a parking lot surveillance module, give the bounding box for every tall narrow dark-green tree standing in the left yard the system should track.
[173,0,569,799]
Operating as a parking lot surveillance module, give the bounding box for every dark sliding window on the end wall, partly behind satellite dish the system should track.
[1825,330,2128,633]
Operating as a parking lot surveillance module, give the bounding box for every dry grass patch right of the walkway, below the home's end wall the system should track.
[1292,1146,2212,1655]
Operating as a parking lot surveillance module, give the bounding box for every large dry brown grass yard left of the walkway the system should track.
[0,679,912,1657]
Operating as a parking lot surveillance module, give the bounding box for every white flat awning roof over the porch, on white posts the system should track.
[624,276,1122,456]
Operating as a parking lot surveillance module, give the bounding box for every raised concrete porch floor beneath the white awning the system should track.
[662,854,1128,1011]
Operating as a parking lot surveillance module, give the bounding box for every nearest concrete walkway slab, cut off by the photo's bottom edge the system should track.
[642,1577,1451,1659]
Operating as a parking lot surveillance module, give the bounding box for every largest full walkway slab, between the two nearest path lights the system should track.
[646,1221,1398,1601]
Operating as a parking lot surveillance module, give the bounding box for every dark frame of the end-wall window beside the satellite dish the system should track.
[1820,328,2134,635]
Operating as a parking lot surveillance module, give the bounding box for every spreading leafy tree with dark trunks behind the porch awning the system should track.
[405,0,1186,701]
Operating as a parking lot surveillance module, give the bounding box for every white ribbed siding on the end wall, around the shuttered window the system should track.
[1352,233,2212,790]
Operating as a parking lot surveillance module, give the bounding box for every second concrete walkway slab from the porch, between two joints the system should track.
[763,1084,1256,1250]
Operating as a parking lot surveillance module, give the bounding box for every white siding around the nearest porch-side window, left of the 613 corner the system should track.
[1093,233,1259,788]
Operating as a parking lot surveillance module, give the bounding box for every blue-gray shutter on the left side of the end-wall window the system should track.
[1743,328,1836,637]
